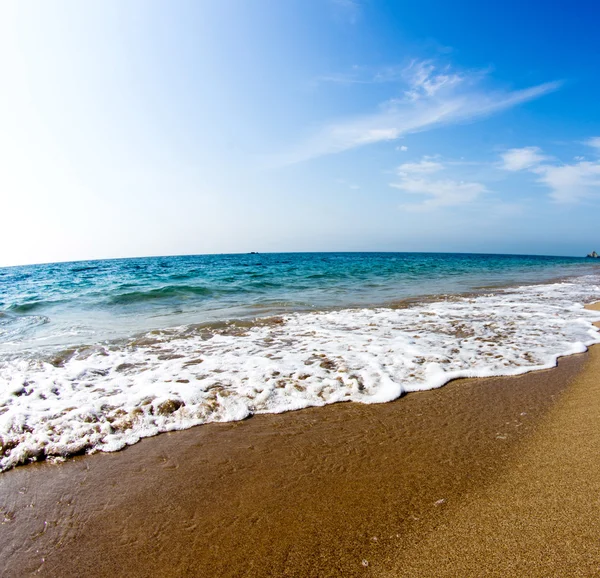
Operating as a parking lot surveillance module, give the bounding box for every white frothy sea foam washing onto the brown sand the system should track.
[0,276,600,470]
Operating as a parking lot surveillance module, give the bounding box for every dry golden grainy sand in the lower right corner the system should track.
[382,304,600,576]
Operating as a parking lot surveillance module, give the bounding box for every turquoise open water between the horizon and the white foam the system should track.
[0,253,598,354]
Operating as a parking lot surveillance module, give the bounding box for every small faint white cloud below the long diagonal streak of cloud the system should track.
[390,157,489,211]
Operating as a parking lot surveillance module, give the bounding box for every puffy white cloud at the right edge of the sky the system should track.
[501,137,600,203]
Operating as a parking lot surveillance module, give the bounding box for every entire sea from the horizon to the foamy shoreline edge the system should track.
[0,253,600,470]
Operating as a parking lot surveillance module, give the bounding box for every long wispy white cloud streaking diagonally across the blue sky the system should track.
[278,61,561,164]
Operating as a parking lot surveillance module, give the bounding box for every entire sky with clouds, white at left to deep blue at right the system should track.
[0,0,600,266]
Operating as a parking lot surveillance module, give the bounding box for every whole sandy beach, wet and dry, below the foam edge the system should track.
[0,304,600,577]
